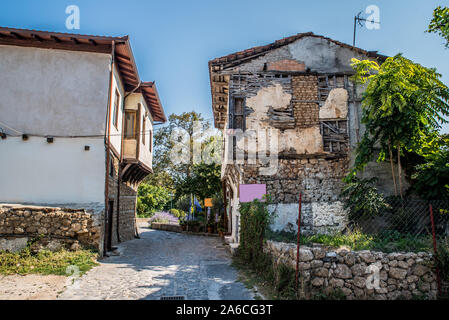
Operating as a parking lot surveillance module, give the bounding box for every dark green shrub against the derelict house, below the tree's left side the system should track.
[341,176,388,221]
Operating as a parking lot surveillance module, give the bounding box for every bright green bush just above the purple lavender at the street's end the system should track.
[137,183,170,217]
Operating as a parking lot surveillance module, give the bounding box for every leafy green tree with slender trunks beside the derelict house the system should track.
[347,54,449,197]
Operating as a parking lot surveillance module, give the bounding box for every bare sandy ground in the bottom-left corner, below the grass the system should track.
[0,274,70,300]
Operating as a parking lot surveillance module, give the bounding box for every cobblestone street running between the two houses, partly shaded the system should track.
[58,228,253,300]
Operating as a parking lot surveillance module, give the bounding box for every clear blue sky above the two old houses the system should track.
[0,0,449,133]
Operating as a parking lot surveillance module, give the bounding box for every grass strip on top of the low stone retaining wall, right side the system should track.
[265,230,432,253]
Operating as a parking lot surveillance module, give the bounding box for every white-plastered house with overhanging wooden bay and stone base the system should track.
[0,28,166,252]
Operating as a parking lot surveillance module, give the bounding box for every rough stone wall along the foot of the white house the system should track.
[0,205,102,251]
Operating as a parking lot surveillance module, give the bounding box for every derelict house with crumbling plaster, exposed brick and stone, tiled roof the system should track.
[209,33,398,242]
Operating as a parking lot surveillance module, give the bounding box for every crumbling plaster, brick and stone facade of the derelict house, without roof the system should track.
[222,37,400,238]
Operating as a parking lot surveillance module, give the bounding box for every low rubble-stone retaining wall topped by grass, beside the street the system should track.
[264,241,437,300]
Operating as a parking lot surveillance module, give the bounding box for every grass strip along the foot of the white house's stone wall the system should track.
[0,247,98,276]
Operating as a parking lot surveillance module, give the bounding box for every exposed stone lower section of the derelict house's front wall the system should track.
[242,158,348,234]
